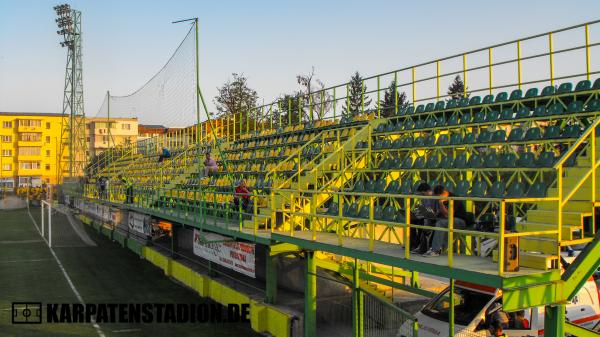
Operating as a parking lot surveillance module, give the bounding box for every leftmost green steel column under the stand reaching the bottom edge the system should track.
[304,252,317,337]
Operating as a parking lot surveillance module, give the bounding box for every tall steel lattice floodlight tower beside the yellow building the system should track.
[54,4,88,182]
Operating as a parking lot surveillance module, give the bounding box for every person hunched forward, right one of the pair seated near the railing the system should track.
[423,185,468,256]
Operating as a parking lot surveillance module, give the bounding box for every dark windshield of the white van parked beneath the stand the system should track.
[422,287,493,326]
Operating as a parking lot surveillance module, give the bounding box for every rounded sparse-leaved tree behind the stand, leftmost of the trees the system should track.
[211,73,260,132]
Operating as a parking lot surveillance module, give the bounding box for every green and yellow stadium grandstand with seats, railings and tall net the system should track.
[57,17,600,336]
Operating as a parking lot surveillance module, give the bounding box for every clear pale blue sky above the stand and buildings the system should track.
[0,0,600,116]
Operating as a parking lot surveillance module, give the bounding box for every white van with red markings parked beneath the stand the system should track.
[399,278,600,337]
